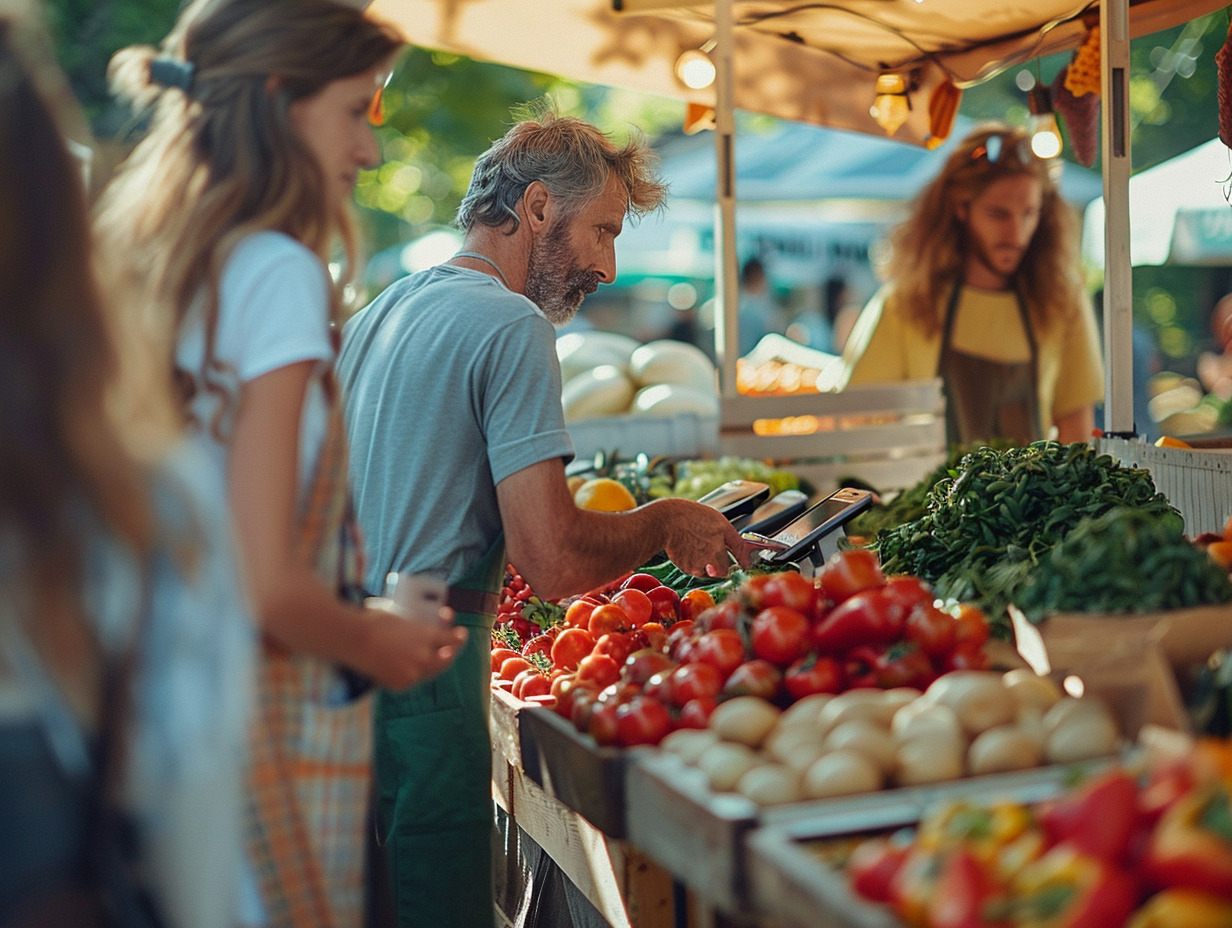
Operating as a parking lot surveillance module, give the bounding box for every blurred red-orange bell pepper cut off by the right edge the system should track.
[1142,784,1232,897]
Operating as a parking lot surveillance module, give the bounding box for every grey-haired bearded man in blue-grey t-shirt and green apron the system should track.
[339,111,750,928]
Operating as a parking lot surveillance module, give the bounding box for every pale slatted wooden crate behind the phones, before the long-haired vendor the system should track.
[718,378,946,492]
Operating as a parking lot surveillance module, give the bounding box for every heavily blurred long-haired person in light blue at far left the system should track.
[0,5,255,928]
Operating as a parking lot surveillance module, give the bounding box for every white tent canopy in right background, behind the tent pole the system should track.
[1083,138,1232,266]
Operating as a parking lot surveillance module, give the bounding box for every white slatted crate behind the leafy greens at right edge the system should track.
[1095,439,1232,536]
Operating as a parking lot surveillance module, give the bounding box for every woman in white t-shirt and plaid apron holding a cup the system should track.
[97,0,466,928]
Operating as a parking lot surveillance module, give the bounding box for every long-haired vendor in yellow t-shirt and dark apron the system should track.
[844,126,1104,444]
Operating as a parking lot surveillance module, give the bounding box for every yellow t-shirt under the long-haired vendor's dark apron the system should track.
[843,286,1104,435]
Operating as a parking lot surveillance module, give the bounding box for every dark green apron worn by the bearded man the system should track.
[375,536,505,928]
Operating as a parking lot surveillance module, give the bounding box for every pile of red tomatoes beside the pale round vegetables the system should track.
[492,548,988,747]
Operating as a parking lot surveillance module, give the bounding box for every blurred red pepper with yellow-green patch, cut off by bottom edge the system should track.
[1011,842,1138,928]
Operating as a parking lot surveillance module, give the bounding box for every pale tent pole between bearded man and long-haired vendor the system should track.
[713,0,739,398]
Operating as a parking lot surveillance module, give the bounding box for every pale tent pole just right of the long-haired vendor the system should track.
[1099,0,1146,436]
